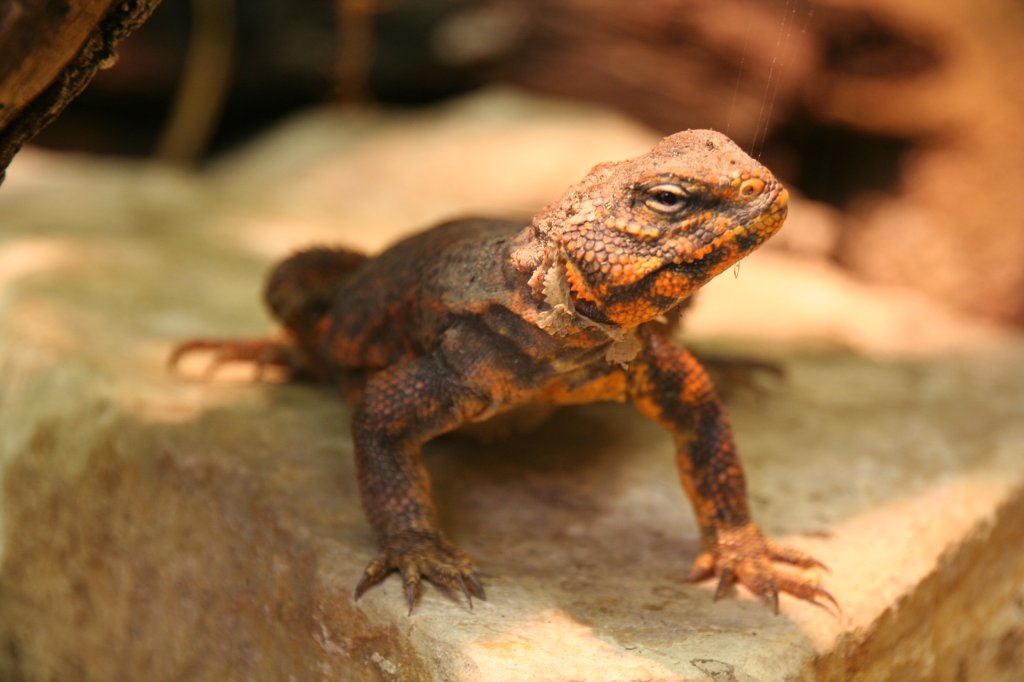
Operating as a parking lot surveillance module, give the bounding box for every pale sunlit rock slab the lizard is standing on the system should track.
[0,89,1024,680]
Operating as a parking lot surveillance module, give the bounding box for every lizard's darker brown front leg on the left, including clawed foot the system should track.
[352,356,487,611]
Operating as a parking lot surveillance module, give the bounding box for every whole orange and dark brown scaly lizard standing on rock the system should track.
[170,130,839,612]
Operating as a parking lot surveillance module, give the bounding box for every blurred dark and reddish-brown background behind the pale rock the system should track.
[6,0,1024,325]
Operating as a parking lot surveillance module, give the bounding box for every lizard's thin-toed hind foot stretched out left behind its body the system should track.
[167,339,303,381]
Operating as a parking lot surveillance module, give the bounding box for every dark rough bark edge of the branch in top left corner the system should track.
[0,0,160,184]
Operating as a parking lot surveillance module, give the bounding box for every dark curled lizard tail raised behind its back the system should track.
[263,247,367,335]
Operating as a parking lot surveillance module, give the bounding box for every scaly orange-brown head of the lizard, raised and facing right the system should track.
[534,130,788,328]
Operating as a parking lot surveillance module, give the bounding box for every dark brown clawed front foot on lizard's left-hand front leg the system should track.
[355,530,486,614]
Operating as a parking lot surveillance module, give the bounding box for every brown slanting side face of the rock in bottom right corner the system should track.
[800,487,1024,682]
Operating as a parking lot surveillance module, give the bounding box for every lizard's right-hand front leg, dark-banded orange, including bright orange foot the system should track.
[629,334,839,612]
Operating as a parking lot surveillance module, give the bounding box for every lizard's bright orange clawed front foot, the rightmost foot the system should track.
[686,523,842,613]
